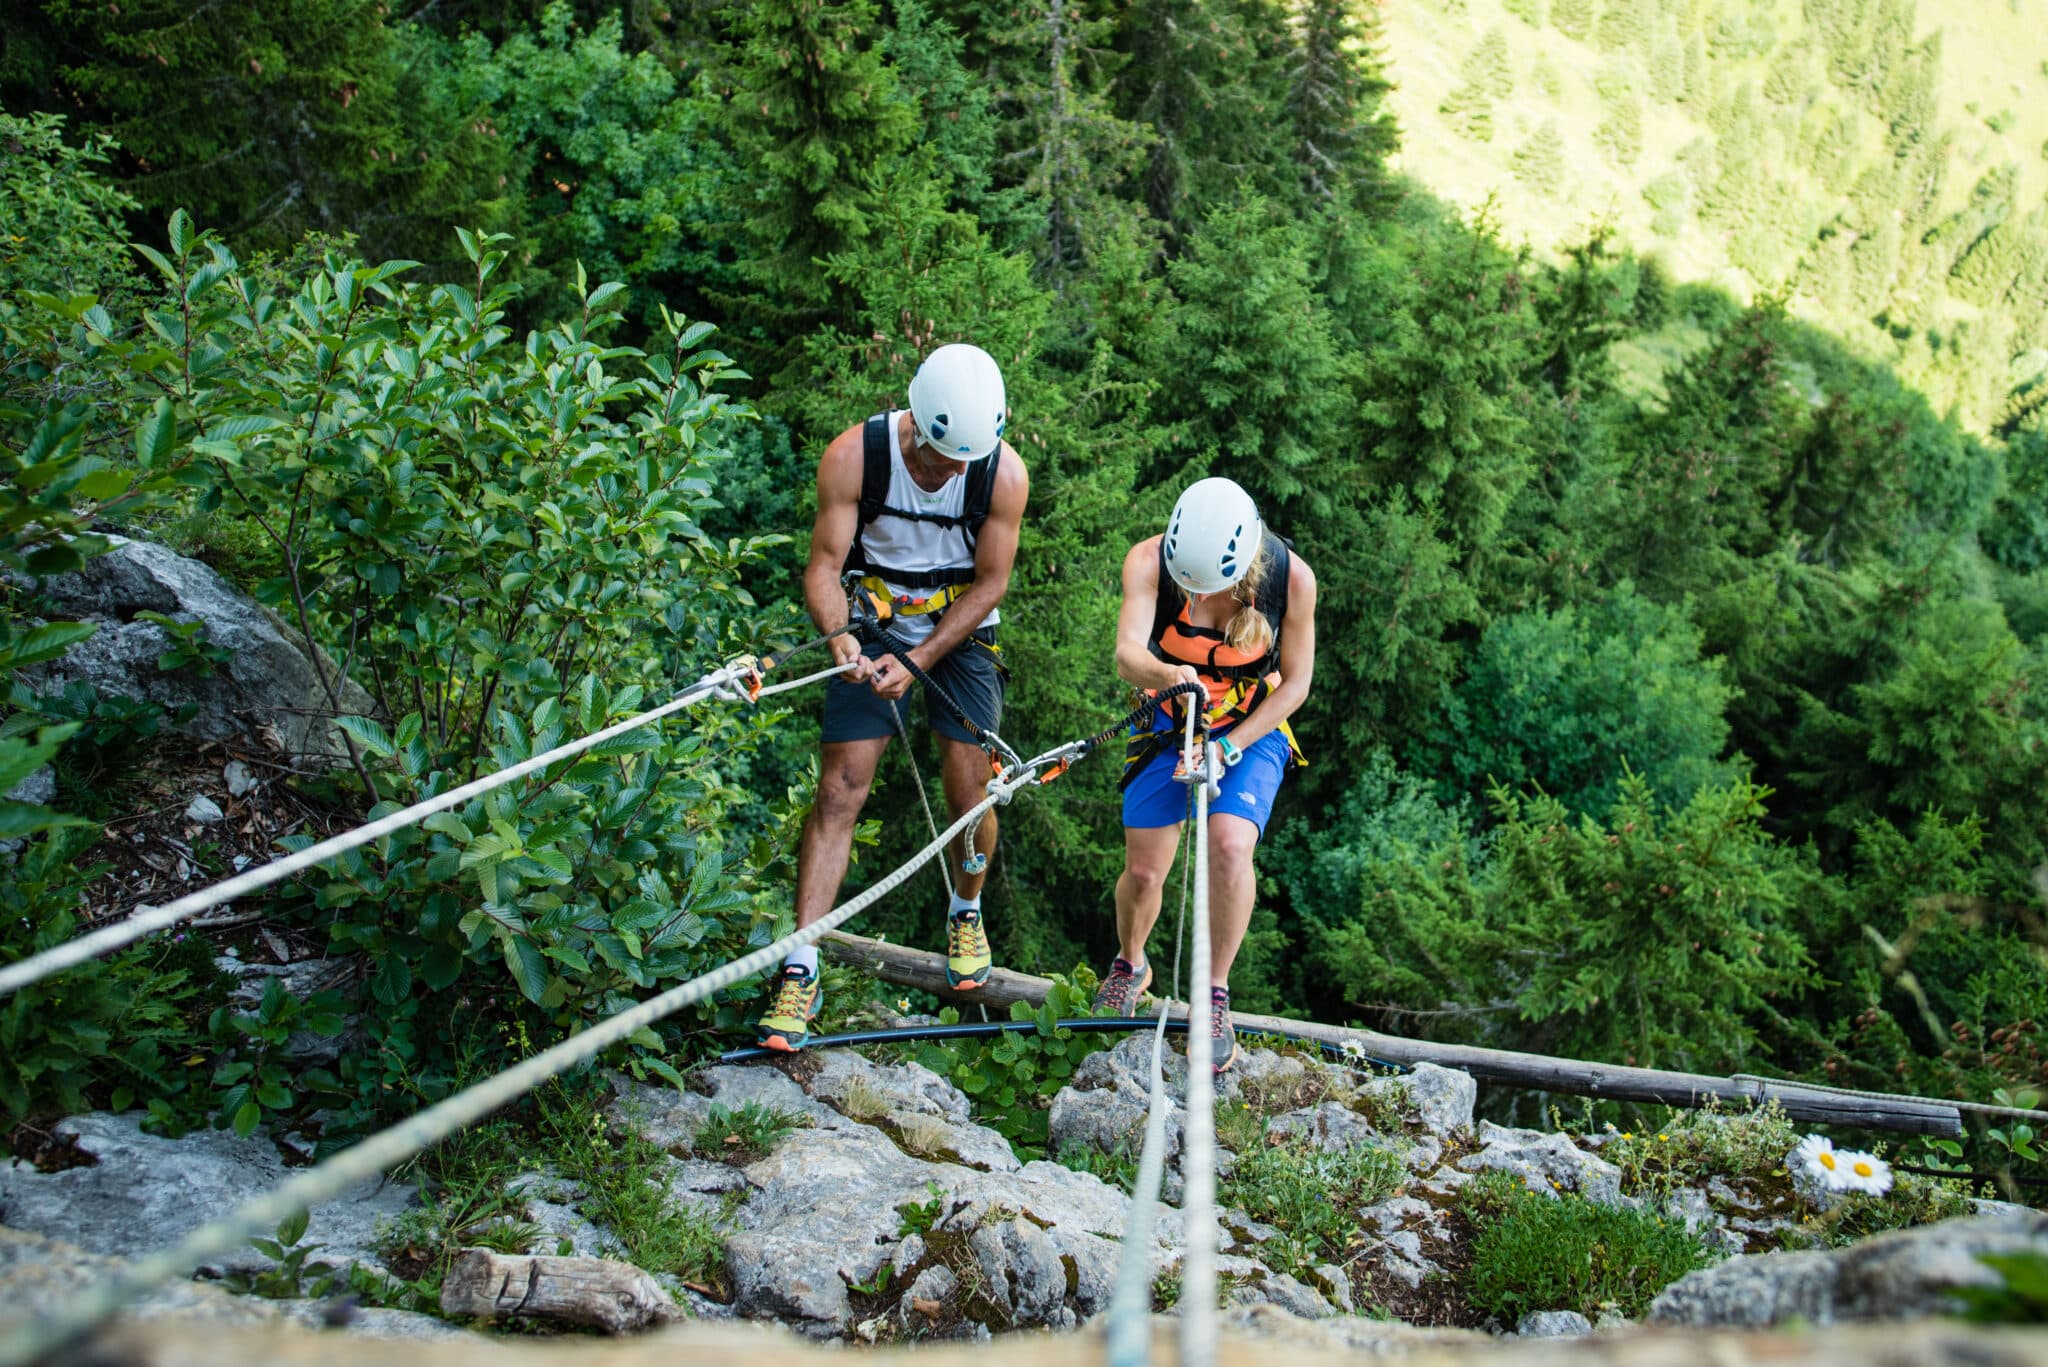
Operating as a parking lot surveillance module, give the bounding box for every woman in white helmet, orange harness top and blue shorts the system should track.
[1096,480,1315,1072]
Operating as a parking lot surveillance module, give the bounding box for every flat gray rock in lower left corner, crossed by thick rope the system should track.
[0,1113,414,1273]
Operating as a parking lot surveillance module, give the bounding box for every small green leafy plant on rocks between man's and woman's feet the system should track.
[918,976,1110,1154]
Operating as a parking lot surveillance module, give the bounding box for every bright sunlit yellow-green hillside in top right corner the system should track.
[1382,0,2048,424]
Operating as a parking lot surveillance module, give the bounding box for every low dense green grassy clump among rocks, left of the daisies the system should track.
[1462,1180,1712,1322]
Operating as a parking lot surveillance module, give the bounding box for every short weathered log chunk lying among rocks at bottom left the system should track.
[440,1248,682,1334]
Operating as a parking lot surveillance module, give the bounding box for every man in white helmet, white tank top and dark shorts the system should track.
[756,344,1030,1049]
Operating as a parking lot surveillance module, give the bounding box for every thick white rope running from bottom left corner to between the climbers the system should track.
[0,767,1036,1367]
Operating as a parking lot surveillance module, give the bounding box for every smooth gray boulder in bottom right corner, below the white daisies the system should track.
[1649,1211,2048,1328]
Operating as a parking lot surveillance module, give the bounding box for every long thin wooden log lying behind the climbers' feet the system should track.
[821,930,1974,1137]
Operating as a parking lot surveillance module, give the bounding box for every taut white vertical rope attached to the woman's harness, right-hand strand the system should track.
[1180,707,1217,1367]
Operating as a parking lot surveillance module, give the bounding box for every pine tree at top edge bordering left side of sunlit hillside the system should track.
[1286,0,1399,209]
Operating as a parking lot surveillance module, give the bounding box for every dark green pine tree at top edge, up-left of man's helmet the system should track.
[721,0,920,315]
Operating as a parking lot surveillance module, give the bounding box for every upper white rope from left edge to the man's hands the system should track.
[0,658,852,996]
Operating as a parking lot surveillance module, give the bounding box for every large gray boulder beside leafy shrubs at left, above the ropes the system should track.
[33,537,375,760]
